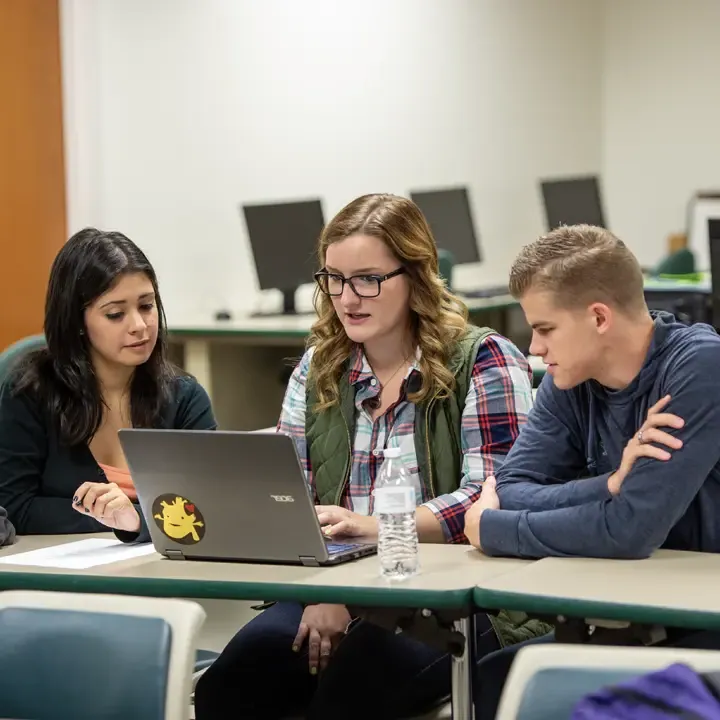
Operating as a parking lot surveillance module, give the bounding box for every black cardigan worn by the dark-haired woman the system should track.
[0,375,217,539]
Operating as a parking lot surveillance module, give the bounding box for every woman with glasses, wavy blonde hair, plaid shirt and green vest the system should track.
[195,195,547,720]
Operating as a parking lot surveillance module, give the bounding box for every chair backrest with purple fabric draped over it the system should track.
[496,643,720,720]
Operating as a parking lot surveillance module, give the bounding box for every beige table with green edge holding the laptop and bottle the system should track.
[0,533,530,720]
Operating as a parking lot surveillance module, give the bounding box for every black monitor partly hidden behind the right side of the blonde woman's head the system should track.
[410,187,482,264]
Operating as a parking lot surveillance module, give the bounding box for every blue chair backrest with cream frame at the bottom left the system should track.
[0,591,205,720]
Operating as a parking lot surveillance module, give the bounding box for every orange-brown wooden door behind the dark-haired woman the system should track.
[0,0,66,350]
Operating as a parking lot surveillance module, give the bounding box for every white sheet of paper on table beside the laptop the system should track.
[0,538,155,570]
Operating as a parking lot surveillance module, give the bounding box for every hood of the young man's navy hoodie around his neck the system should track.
[590,310,717,404]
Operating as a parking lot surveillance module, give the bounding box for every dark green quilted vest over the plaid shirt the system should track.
[305,326,552,645]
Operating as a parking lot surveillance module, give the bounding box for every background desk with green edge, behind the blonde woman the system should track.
[169,295,528,430]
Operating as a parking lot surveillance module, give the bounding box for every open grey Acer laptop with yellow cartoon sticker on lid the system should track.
[119,429,377,567]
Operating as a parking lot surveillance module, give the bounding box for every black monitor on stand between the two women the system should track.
[242,200,325,315]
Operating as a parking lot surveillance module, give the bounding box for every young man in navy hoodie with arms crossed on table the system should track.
[465,225,720,558]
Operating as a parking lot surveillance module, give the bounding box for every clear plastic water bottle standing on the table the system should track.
[373,448,420,580]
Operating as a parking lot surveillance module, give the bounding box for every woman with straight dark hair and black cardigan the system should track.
[0,228,216,540]
